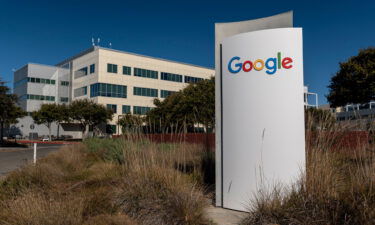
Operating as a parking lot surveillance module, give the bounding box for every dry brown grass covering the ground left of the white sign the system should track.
[0,139,212,225]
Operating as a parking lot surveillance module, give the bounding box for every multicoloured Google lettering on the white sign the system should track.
[228,52,293,75]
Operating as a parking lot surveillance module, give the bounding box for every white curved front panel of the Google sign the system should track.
[216,11,305,211]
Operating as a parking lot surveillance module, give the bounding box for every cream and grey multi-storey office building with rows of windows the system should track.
[14,46,215,138]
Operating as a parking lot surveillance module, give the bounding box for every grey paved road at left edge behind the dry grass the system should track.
[0,144,62,177]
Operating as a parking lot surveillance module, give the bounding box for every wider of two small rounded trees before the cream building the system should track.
[69,99,113,138]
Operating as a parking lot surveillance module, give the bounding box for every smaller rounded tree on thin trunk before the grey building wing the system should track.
[31,103,65,141]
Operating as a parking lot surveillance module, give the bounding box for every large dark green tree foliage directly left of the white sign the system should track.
[146,77,215,132]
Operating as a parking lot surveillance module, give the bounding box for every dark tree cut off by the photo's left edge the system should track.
[0,78,26,143]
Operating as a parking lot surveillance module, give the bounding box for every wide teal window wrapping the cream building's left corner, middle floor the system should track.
[90,83,127,98]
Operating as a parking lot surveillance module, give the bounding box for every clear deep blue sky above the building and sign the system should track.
[0,0,375,104]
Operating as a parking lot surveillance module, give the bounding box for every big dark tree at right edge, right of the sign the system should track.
[327,48,375,107]
